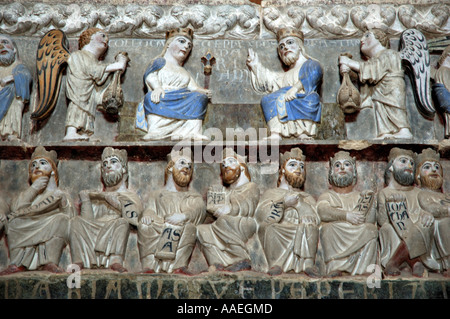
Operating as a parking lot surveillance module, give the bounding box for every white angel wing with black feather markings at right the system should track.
[400,29,436,119]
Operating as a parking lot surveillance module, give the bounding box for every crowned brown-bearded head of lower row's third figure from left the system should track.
[164,147,194,187]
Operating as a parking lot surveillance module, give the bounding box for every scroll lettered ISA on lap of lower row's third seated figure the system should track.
[155,223,184,260]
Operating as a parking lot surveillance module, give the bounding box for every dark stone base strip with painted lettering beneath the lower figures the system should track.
[0,270,450,305]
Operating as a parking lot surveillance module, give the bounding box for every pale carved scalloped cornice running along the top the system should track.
[0,2,450,39]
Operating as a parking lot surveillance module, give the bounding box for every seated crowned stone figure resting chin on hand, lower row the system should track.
[0,146,74,275]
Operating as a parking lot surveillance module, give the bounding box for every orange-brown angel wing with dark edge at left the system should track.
[31,29,70,121]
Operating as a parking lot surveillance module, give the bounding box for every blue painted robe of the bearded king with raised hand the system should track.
[261,59,323,123]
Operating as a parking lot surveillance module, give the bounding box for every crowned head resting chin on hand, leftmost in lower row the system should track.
[28,146,59,185]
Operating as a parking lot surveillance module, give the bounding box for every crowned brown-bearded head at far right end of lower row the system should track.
[415,148,444,190]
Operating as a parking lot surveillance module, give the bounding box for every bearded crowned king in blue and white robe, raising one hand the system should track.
[247,28,323,139]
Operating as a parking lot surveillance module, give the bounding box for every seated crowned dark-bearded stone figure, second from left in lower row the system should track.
[70,147,143,272]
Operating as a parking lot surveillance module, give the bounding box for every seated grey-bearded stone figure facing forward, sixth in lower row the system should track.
[317,151,378,277]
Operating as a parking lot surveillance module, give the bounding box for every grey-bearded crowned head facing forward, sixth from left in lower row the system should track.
[328,151,358,187]
